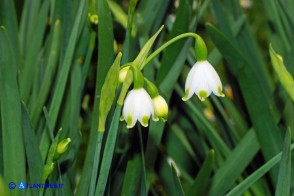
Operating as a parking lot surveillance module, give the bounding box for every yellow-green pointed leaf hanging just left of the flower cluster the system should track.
[98,53,122,132]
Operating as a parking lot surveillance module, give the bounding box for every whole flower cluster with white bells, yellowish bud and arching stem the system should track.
[101,27,224,130]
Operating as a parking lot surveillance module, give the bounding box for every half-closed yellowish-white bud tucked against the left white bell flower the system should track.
[152,95,168,121]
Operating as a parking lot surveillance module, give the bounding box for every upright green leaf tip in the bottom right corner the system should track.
[275,129,291,196]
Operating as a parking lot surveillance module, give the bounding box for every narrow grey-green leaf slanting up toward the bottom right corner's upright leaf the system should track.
[227,144,294,196]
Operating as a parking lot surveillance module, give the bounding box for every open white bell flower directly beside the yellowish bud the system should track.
[122,88,156,128]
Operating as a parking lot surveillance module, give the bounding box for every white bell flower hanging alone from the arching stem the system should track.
[182,60,225,101]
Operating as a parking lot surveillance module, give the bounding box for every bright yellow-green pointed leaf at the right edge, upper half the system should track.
[269,45,294,101]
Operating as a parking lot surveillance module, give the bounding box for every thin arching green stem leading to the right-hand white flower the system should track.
[142,32,206,69]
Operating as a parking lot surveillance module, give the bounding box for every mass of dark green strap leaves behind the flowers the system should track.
[0,0,294,195]
